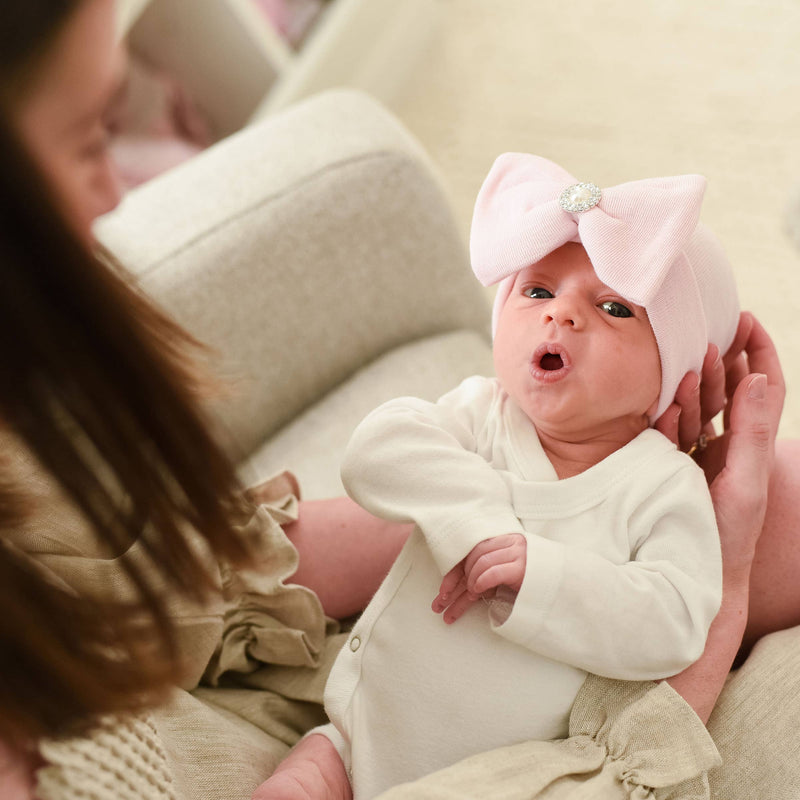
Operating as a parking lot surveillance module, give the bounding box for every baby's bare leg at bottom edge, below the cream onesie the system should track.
[252,734,353,800]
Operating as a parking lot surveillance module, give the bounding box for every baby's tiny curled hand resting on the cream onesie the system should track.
[431,533,528,625]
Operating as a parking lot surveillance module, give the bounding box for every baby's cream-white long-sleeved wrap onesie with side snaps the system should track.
[316,377,722,800]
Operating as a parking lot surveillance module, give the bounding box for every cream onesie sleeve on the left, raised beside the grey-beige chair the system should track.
[342,377,523,574]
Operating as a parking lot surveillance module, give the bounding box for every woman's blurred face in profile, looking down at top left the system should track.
[16,0,125,241]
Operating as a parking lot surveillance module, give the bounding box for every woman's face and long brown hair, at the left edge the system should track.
[0,0,406,788]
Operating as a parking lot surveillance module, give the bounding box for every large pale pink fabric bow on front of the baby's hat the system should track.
[470,153,706,306]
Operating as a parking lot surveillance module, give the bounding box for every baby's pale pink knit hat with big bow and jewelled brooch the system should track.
[470,153,739,422]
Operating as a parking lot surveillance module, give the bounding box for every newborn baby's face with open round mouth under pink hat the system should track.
[494,243,661,446]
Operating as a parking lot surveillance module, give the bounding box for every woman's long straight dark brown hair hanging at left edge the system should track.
[0,0,253,745]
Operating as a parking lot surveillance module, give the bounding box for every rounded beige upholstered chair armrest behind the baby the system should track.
[96,90,489,457]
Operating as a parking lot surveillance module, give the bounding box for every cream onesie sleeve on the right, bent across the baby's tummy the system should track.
[492,464,722,680]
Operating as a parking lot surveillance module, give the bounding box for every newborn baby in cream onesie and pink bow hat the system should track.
[264,153,739,800]
